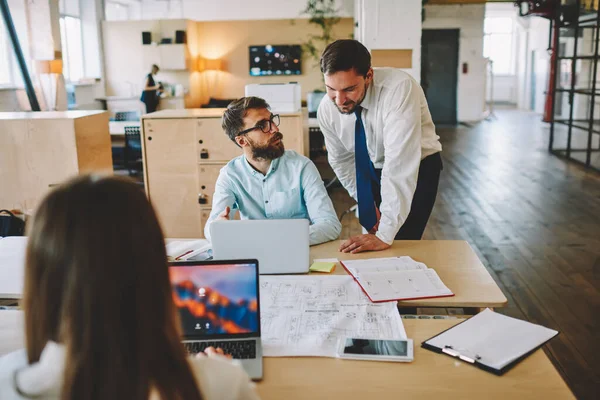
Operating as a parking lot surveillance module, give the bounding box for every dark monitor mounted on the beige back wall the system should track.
[249,44,302,76]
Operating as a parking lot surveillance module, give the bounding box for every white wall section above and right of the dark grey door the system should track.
[423,4,485,121]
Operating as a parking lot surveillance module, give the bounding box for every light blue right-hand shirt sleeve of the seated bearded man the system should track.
[301,160,342,246]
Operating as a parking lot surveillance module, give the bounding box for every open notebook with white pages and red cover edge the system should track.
[340,256,454,303]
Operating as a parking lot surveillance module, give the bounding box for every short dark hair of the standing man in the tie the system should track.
[320,39,371,76]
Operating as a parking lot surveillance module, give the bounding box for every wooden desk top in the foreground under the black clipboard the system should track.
[257,320,574,400]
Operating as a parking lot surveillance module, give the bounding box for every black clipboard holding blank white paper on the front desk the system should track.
[421,308,558,375]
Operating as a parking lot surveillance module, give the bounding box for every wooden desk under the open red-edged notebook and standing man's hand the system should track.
[310,240,507,308]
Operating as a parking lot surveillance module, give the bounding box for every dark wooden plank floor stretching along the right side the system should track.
[319,110,600,399]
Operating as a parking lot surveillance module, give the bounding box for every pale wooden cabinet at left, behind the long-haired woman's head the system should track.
[0,111,113,211]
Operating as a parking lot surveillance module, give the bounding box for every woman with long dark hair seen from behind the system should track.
[0,176,257,400]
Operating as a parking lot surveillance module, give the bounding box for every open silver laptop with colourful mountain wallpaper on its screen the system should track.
[169,259,262,380]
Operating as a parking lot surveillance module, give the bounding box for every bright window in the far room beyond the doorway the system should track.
[483,17,514,75]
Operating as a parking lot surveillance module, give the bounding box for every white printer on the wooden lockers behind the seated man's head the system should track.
[245,83,301,113]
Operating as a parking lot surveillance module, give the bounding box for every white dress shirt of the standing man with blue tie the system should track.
[317,68,442,244]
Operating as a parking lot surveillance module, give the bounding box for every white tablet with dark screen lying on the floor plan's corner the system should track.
[338,337,413,362]
